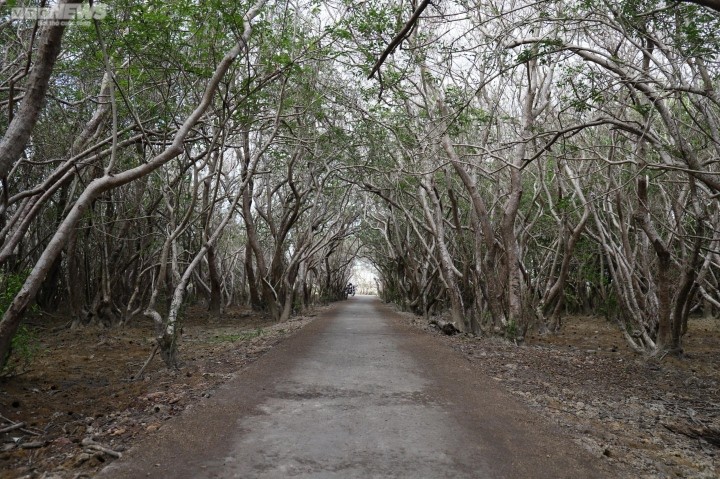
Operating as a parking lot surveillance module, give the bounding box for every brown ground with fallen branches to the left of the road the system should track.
[0,308,315,479]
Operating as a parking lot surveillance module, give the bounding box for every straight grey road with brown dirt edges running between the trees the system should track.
[98,296,616,479]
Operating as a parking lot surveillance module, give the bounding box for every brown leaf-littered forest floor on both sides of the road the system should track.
[0,309,720,478]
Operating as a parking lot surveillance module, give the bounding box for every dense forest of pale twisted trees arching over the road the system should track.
[0,0,720,372]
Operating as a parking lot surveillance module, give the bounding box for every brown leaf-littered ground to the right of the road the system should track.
[404,313,720,479]
